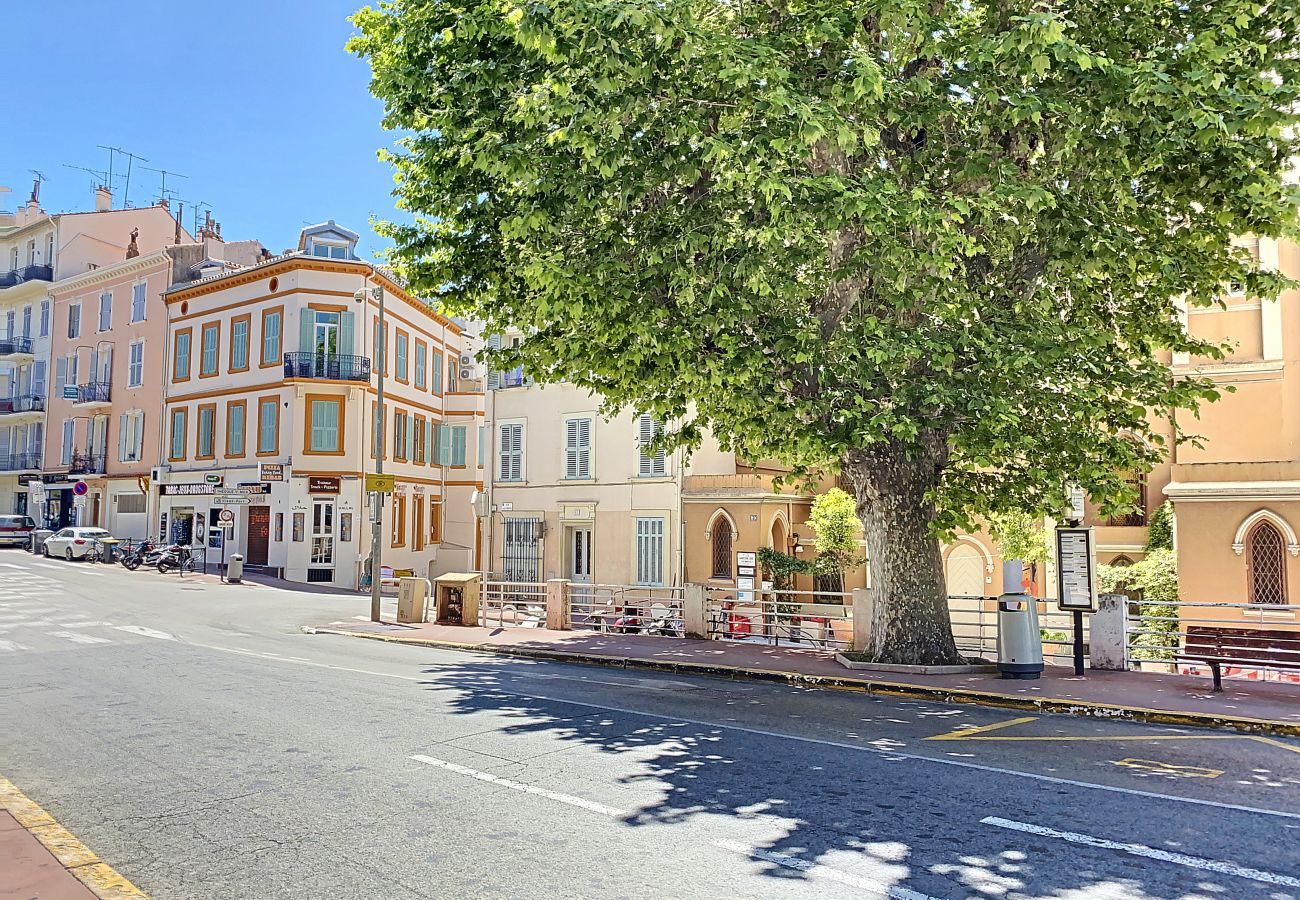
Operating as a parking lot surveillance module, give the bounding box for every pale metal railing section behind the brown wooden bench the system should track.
[1125,600,1300,682]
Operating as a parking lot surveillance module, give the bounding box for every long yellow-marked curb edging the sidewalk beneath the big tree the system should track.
[303,626,1300,737]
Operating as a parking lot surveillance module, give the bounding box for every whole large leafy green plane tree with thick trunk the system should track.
[351,0,1300,663]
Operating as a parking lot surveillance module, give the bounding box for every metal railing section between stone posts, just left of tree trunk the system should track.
[705,588,853,650]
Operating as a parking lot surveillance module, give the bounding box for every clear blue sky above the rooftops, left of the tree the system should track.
[0,0,405,256]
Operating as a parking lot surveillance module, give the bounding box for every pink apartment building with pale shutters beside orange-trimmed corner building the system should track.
[44,234,264,538]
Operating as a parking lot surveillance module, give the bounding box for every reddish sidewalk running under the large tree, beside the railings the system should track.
[304,622,1300,736]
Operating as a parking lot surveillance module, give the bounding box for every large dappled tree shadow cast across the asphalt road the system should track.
[408,659,1258,900]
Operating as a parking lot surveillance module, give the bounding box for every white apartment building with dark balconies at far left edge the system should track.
[0,182,190,524]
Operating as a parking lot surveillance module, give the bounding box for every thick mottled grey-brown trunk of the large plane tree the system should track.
[844,453,962,666]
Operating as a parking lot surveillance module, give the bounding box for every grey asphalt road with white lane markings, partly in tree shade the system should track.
[0,551,1300,900]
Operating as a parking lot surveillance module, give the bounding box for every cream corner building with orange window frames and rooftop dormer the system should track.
[159,221,482,588]
